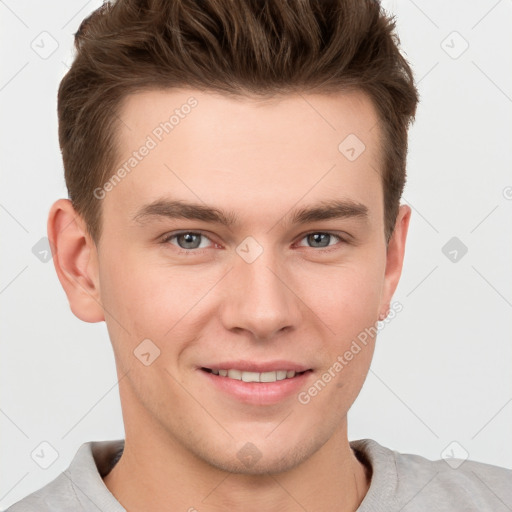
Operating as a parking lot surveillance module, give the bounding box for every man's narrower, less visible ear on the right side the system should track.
[379,205,411,320]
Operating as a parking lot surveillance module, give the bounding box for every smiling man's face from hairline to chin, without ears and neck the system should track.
[91,90,404,473]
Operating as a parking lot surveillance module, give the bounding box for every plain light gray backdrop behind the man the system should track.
[0,0,512,509]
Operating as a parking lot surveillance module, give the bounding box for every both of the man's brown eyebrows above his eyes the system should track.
[133,199,368,228]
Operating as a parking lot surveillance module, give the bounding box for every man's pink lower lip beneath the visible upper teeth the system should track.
[199,369,312,405]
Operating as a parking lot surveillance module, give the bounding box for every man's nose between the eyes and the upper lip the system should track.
[221,247,300,340]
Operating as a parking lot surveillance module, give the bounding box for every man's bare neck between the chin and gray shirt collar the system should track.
[104,421,369,512]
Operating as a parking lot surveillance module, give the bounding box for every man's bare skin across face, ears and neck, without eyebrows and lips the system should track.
[48,90,411,512]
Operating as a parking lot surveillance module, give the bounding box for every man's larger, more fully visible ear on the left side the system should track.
[48,199,105,322]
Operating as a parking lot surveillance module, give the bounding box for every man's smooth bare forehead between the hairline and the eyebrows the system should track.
[104,89,382,228]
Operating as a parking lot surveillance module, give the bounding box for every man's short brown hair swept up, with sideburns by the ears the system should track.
[58,0,418,243]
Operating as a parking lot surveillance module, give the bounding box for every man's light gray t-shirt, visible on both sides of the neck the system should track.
[7,439,512,512]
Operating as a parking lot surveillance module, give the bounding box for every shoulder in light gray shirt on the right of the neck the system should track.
[351,439,512,512]
